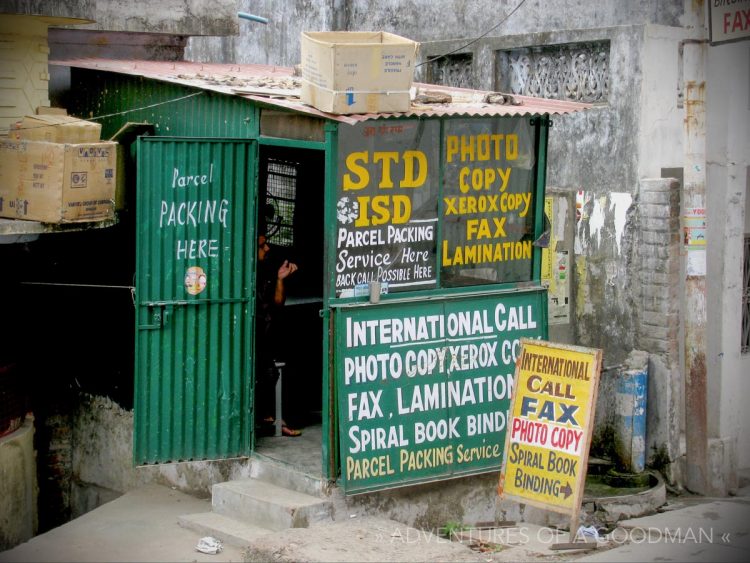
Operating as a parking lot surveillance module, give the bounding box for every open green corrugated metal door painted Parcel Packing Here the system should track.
[134,137,257,464]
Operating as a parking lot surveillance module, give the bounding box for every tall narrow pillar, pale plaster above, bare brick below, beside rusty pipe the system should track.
[638,25,695,483]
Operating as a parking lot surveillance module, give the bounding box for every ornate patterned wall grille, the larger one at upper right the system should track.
[497,41,609,103]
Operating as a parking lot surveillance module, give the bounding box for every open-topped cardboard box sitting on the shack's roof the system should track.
[300,31,419,114]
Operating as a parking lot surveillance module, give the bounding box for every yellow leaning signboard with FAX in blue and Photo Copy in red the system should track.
[498,339,602,530]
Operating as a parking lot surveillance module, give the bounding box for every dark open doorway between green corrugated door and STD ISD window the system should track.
[256,146,325,470]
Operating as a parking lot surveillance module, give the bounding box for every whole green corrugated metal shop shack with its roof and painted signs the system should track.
[54,59,585,493]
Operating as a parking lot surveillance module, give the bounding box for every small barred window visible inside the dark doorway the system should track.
[266,158,299,246]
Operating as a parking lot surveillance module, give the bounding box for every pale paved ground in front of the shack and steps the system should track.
[0,485,750,563]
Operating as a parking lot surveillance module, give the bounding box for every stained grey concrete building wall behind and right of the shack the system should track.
[186,0,686,374]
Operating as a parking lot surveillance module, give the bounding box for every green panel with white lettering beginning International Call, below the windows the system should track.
[334,290,547,494]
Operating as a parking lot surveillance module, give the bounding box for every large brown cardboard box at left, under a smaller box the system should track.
[0,140,117,223]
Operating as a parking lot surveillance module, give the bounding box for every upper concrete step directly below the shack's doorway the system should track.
[211,479,333,530]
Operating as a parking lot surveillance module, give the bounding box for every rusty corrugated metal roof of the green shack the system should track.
[49,59,592,123]
